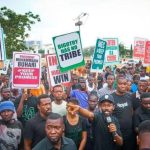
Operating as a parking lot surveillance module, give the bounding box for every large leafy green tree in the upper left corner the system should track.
[0,7,40,58]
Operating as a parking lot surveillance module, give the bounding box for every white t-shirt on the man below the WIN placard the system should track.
[52,100,67,116]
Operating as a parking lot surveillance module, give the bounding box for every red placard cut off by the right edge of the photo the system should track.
[144,41,150,65]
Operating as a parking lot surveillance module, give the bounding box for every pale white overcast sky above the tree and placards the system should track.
[0,0,150,47]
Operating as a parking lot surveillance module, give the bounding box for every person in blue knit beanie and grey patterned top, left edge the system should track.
[0,101,23,150]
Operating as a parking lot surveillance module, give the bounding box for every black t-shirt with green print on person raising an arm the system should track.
[14,96,38,126]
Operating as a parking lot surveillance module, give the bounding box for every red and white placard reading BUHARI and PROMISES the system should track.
[12,52,41,89]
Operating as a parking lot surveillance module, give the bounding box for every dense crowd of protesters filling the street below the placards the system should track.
[0,62,150,150]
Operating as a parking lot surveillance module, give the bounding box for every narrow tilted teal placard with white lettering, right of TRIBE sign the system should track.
[91,39,106,72]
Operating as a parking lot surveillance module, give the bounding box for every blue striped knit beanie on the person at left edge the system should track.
[0,101,15,113]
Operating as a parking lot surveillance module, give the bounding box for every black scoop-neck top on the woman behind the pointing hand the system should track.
[63,116,87,148]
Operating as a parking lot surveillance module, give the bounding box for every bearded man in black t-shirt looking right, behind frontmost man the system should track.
[24,94,51,150]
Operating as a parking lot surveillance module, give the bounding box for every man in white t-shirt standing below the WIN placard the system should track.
[52,85,67,116]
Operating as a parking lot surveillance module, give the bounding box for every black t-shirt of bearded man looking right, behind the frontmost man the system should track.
[24,113,46,148]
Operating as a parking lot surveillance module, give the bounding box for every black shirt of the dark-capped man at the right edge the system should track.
[133,107,150,129]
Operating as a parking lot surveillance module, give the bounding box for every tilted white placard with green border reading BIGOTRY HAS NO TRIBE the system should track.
[53,31,85,72]
